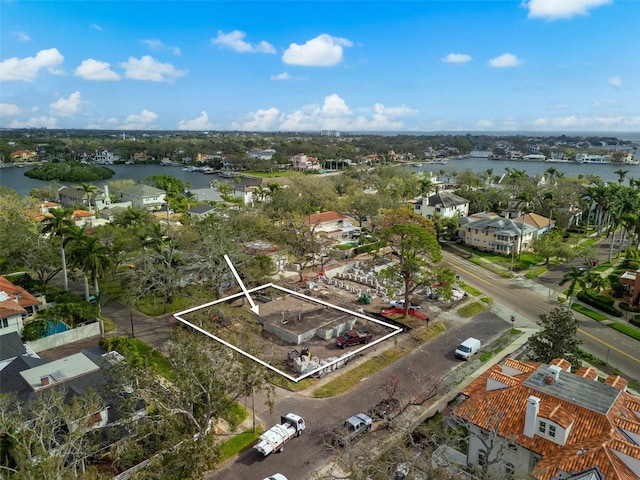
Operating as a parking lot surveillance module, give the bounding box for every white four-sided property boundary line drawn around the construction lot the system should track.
[173,283,402,383]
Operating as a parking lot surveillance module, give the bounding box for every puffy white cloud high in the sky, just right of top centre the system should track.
[282,33,353,67]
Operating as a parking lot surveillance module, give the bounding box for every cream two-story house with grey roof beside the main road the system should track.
[458,212,537,255]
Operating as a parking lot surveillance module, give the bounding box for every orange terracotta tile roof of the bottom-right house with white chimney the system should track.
[453,359,640,480]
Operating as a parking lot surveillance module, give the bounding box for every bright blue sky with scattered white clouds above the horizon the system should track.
[0,0,640,133]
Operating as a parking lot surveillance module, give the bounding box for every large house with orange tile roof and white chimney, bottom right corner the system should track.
[453,358,640,480]
